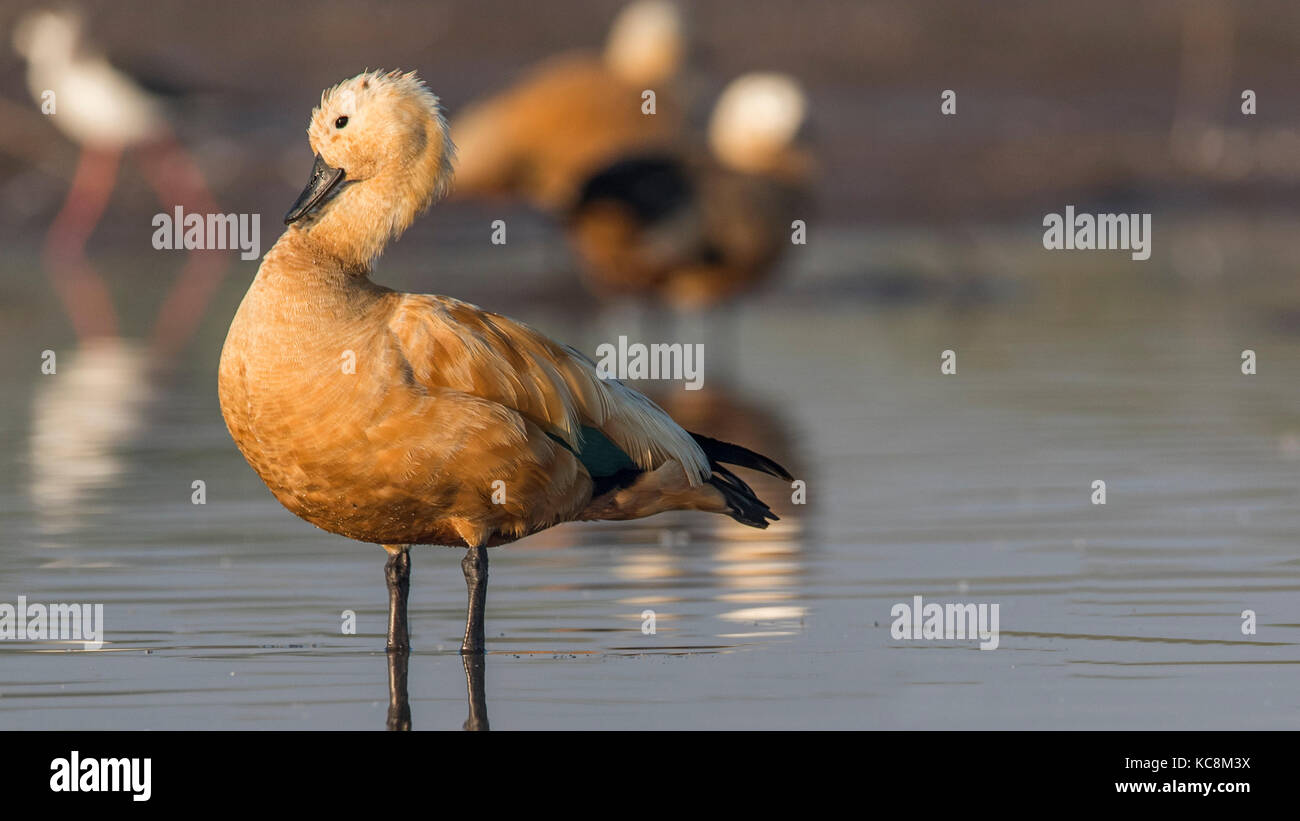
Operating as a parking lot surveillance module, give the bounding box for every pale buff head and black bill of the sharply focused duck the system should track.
[285,71,455,269]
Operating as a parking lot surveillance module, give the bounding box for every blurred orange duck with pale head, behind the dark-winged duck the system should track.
[452,0,683,213]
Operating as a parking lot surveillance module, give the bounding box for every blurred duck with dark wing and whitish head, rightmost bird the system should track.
[568,74,811,310]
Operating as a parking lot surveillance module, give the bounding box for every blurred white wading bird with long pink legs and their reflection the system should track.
[13,10,222,352]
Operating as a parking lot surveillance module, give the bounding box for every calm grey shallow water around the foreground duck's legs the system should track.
[0,233,1300,729]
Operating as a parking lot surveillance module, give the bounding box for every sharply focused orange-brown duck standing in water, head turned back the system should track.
[217,71,790,653]
